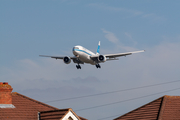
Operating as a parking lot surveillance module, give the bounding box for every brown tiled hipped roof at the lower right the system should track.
[114,95,180,120]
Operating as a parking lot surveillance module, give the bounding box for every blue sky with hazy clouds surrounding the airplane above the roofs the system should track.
[0,0,180,120]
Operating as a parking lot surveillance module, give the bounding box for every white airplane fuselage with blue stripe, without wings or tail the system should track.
[73,45,97,65]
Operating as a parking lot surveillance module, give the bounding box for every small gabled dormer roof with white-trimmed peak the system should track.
[40,108,87,120]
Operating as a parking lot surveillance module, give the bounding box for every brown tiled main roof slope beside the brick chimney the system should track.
[0,92,57,120]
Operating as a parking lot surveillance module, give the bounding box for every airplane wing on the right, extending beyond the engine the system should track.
[104,50,145,60]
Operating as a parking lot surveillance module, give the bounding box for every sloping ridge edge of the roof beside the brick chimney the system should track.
[11,92,58,109]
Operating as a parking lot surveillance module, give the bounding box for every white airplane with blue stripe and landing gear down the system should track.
[39,41,145,69]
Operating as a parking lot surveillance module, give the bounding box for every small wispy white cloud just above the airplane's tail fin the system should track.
[101,29,119,43]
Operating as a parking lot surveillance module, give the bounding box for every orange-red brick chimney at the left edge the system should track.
[0,82,13,106]
